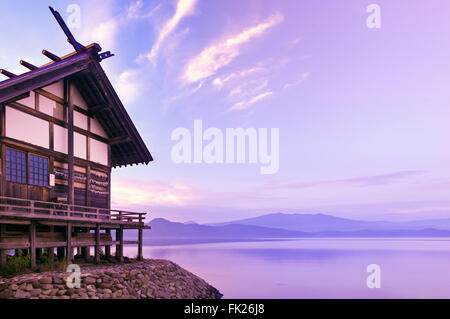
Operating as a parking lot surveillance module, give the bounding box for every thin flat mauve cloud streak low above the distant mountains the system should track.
[263,171,424,189]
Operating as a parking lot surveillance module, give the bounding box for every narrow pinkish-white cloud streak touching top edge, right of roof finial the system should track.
[138,0,197,64]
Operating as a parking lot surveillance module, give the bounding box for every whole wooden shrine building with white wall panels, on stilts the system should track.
[0,8,152,266]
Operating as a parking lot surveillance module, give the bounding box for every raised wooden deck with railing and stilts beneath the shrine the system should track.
[0,196,150,266]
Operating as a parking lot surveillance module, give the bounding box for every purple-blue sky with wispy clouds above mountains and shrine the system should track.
[0,0,450,222]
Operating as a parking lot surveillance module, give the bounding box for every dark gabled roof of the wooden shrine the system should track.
[0,44,153,167]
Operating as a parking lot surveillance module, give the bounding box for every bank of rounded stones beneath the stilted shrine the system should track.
[0,259,222,299]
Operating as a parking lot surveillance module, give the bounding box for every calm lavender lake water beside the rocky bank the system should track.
[125,238,450,298]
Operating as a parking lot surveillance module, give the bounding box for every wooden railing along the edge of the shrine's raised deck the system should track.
[0,196,146,223]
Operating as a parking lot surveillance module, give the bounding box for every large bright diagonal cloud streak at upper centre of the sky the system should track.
[182,13,283,84]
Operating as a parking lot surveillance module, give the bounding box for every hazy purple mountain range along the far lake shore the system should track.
[125,213,450,245]
